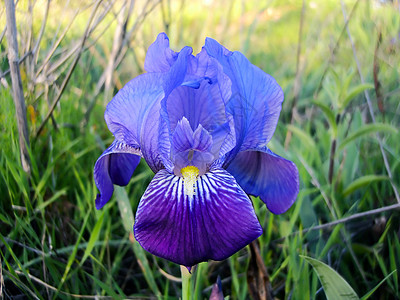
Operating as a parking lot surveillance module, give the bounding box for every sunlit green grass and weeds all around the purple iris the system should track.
[0,0,400,299]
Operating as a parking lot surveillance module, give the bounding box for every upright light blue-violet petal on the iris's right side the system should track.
[205,38,283,163]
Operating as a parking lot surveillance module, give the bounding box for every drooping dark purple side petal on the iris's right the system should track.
[227,147,299,214]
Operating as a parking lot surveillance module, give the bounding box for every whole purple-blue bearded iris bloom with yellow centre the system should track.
[94,33,299,267]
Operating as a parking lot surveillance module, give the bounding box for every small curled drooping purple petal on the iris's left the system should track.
[94,140,141,209]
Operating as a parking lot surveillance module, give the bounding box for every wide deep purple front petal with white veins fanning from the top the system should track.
[134,169,262,267]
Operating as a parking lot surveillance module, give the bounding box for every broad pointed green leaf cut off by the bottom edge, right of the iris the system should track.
[300,255,360,300]
